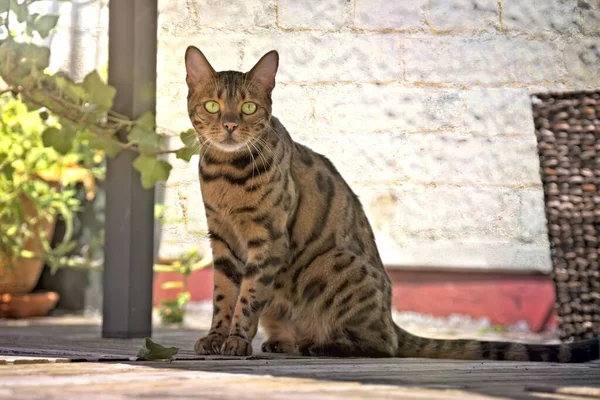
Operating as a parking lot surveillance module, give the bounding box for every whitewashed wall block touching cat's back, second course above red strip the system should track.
[356,185,520,241]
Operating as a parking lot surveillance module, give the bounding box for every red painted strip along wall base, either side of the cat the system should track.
[154,268,556,332]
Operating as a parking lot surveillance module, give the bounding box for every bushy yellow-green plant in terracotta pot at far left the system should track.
[0,94,103,317]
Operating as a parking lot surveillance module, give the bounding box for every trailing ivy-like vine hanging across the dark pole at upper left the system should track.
[0,0,200,188]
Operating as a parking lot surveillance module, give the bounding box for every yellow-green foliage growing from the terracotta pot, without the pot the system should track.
[0,95,104,269]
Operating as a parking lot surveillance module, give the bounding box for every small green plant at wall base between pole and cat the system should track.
[154,250,211,325]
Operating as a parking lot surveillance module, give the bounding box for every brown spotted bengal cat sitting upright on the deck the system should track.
[185,46,599,362]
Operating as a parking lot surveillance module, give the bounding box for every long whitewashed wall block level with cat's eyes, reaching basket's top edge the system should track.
[314,84,533,136]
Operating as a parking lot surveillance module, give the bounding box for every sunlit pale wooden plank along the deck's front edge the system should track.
[0,364,506,400]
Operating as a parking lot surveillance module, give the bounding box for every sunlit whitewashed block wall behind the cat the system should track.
[45,0,600,271]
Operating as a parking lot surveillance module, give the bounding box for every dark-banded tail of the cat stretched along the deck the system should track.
[396,326,600,363]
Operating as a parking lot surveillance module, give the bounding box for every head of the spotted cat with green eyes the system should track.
[185,46,279,152]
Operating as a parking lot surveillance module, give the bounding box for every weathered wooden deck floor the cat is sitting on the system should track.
[0,323,600,400]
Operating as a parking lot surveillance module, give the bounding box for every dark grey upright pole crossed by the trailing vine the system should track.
[102,0,158,338]
